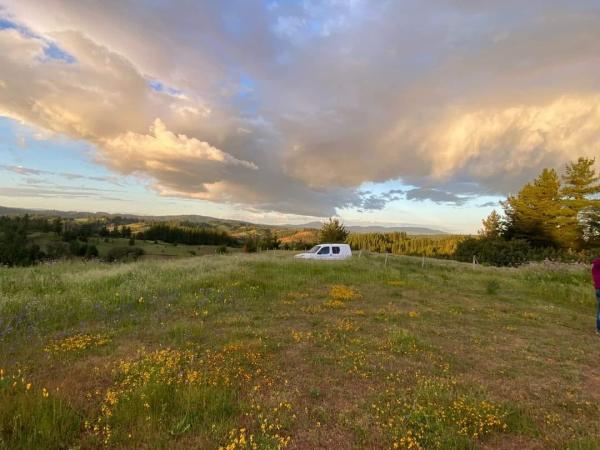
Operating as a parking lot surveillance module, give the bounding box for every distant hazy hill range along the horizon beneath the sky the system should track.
[0,206,447,235]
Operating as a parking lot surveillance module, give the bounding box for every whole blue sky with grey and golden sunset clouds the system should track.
[0,0,600,233]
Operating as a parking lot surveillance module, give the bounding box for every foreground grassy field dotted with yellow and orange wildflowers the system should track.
[0,252,600,450]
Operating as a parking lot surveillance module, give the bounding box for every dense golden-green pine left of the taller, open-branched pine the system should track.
[502,169,561,247]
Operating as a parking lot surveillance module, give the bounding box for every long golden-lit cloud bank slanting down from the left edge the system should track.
[0,25,353,215]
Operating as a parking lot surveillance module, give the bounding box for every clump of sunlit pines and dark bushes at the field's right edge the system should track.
[455,158,600,265]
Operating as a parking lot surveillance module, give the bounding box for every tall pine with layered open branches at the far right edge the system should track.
[558,157,600,249]
